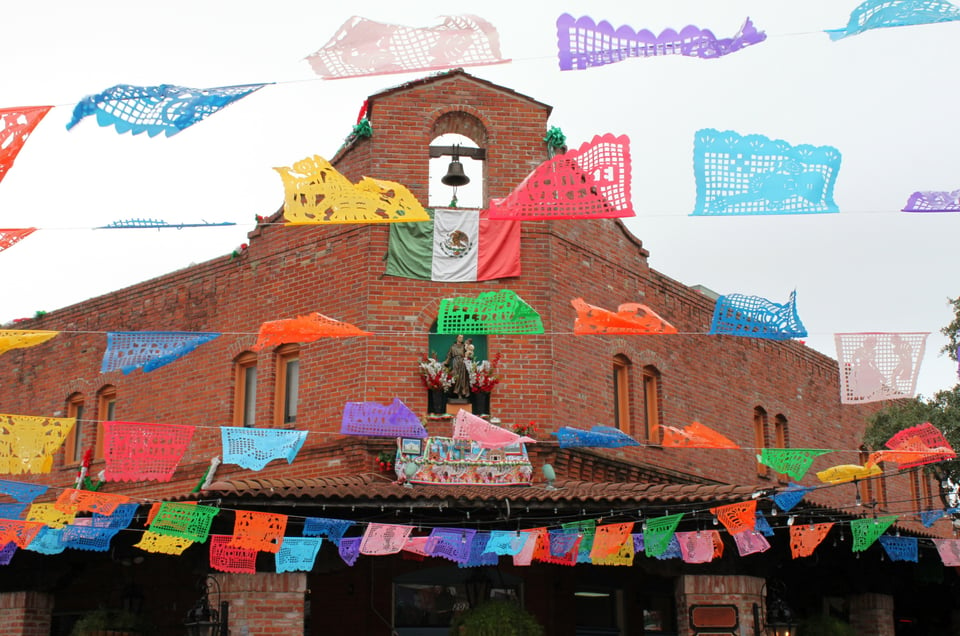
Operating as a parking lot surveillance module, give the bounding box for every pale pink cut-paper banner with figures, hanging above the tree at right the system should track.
[834,333,929,404]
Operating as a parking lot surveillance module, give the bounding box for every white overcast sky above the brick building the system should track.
[0,0,960,395]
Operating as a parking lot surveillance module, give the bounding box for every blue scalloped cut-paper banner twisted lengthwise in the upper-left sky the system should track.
[67,84,265,137]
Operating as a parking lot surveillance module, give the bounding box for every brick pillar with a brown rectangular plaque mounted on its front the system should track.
[676,574,764,636]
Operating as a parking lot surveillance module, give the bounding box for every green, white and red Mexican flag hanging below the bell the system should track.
[386,208,520,282]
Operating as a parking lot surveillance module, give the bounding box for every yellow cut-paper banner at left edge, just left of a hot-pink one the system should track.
[0,415,76,475]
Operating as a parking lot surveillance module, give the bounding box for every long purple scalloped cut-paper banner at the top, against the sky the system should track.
[557,13,767,71]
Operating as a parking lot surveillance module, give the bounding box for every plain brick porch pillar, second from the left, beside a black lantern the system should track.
[217,572,307,636]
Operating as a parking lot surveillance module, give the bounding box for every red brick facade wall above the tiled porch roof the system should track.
[0,73,924,528]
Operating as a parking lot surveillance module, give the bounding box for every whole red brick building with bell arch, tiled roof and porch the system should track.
[0,70,955,636]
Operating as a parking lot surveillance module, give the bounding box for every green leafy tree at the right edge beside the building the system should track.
[864,297,960,507]
